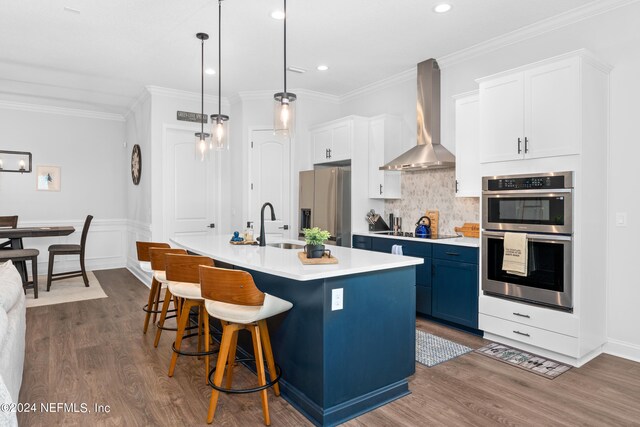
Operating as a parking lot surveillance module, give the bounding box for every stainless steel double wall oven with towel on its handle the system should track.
[482,172,573,311]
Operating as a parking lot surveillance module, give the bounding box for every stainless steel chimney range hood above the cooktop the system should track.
[380,58,456,171]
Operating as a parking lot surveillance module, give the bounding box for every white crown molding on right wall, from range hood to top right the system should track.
[438,0,640,68]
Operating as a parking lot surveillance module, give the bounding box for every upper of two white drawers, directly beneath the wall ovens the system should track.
[480,296,580,337]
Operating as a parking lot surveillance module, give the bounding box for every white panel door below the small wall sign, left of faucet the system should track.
[163,127,219,238]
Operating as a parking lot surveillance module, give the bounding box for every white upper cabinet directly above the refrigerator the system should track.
[310,118,353,164]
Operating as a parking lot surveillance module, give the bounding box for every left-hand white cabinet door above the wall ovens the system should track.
[480,73,524,163]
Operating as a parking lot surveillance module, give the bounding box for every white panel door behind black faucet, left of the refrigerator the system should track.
[249,130,291,243]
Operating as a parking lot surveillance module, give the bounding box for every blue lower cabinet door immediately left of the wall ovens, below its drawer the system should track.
[431,259,478,329]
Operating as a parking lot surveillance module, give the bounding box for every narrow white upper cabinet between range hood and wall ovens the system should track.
[454,91,482,197]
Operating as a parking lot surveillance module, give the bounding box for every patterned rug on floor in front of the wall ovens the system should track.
[476,342,571,379]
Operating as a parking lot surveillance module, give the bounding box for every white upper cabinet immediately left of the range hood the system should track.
[368,114,402,199]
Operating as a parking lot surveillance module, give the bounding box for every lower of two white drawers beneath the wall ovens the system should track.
[479,313,580,357]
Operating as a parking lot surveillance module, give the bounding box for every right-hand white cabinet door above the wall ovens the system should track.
[524,58,582,158]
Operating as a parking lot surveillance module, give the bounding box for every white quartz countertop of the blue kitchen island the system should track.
[170,235,424,281]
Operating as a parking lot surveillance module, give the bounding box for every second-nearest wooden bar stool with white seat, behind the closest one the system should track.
[162,254,215,378]
